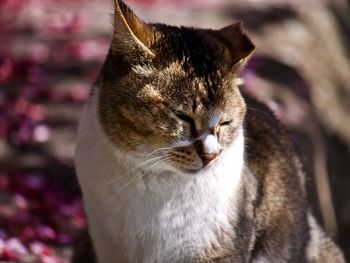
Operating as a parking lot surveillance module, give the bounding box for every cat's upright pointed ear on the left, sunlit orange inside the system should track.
[111,0,155,60]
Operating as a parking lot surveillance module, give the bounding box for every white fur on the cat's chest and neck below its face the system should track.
[76,94,244,263]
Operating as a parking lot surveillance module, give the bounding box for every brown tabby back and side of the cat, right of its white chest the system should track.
[244,94,345,263]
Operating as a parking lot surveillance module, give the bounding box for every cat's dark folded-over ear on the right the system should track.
[219,22,255,66]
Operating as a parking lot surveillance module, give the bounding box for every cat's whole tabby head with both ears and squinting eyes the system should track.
[98,0,254,175]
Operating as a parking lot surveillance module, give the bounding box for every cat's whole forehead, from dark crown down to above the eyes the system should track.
[133,25,234,108]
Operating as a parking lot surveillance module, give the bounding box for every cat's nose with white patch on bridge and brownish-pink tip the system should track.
[194,134,219,166]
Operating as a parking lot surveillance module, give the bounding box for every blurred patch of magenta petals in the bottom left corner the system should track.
[0,173,86,262]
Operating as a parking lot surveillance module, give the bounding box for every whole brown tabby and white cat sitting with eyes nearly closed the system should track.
[73,0,345,263]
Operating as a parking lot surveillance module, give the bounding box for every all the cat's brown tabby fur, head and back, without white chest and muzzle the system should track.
[73,1,345,263]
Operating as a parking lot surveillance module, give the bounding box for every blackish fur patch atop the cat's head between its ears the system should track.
[154,25,231,79]
